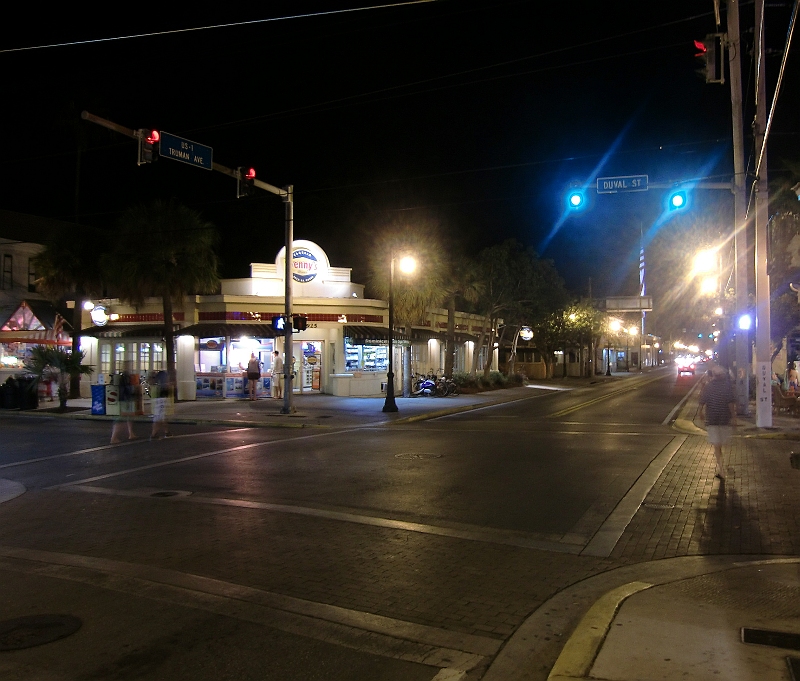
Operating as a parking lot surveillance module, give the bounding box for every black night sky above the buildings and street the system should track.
[0,0,800,310]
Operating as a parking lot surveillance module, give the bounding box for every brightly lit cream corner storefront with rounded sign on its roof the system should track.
[81,241,490,400]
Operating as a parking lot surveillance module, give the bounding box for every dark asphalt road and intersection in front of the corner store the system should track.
[0,372,696,681]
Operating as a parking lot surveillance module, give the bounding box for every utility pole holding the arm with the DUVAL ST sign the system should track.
[728,0,750,416]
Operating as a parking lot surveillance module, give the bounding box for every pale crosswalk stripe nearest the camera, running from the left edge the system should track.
[0,546,494,680]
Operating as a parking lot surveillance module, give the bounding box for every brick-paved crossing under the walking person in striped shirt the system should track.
[611,436,800,562]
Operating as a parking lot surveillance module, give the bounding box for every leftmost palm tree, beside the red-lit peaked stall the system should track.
[33,225,106,399]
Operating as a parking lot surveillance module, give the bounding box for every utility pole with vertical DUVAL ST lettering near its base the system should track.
[753,0,772,428]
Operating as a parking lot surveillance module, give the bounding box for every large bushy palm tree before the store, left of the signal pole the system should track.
[104,200,219,383]
